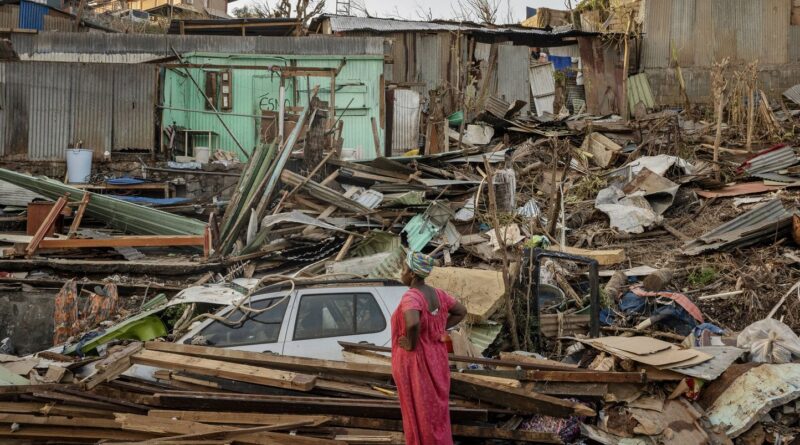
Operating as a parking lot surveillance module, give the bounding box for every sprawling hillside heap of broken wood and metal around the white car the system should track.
[0,40,800,444]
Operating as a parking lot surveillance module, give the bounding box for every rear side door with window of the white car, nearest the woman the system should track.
[283,287,391,360]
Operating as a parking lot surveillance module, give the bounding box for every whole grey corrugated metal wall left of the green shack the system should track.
[0,62,157,160]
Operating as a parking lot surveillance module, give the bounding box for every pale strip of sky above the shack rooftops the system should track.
[230,0,577,23]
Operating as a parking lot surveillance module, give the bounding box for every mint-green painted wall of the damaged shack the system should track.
[162,53,384,159]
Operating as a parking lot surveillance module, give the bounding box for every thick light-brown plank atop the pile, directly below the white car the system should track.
[131,343,316,391]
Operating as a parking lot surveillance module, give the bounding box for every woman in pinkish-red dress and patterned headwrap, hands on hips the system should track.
[392,252,467,445]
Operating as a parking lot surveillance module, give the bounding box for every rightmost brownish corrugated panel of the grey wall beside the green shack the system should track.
[113,65,158,150]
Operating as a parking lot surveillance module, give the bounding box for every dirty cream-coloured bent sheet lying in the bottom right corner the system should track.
[706,363,800,438]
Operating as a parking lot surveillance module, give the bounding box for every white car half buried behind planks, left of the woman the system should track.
[177,280,408,360]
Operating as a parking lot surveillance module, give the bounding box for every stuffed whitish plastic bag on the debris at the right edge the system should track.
[736,318,800,364]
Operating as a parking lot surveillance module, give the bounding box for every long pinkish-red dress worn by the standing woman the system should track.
[392,289,456,445]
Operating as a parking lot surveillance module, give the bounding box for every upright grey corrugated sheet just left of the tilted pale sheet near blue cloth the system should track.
[497,45,531,113]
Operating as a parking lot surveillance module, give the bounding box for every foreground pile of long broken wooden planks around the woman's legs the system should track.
[0,342,612,445]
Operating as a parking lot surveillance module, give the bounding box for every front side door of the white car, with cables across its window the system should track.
[183,295,292,354]
